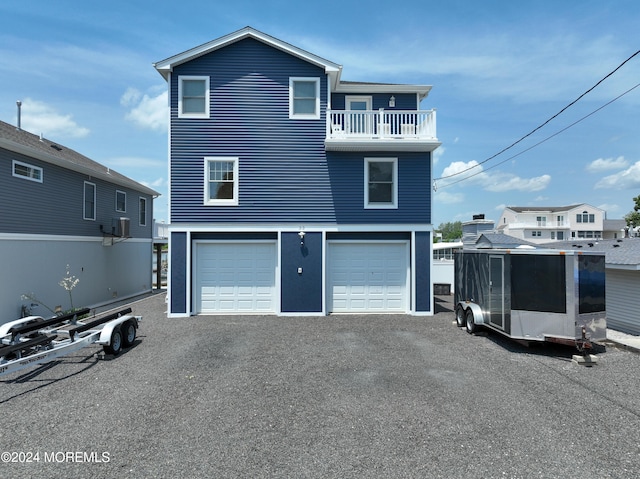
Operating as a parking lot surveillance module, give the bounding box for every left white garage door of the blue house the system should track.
[194,242,276,314]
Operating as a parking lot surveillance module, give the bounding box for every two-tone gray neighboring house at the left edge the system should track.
[0,121,159,324]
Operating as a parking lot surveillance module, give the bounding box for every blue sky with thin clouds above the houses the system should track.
[0,0,640,226]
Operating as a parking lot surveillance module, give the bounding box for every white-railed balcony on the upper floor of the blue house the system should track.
[325,109,441,152]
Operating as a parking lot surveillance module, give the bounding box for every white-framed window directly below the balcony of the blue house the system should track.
[364,158,398,208]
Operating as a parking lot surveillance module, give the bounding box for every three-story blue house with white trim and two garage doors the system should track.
[154,27,440,317]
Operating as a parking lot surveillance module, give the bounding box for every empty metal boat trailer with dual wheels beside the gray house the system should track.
[0,308,142,376]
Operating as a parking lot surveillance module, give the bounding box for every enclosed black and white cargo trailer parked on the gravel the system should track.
[455,249,607,350]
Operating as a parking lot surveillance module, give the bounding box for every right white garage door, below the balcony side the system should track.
[327,242,409,313]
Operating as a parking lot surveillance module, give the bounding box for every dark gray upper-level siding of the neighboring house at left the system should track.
[0,148,153,238]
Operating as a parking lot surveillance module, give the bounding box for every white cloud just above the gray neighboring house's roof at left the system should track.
[21,98,90,138]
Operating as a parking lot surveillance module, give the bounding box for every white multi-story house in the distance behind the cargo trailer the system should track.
[496,203,623,243]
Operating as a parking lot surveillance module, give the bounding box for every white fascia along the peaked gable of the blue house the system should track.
[153,27,342,84]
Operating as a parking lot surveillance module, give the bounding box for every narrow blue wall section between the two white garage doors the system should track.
[281,232,322,313]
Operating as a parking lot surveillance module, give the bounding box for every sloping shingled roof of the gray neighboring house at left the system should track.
[0,121,160,196]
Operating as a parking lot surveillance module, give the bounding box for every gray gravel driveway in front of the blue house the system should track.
[0,295,640,478]
